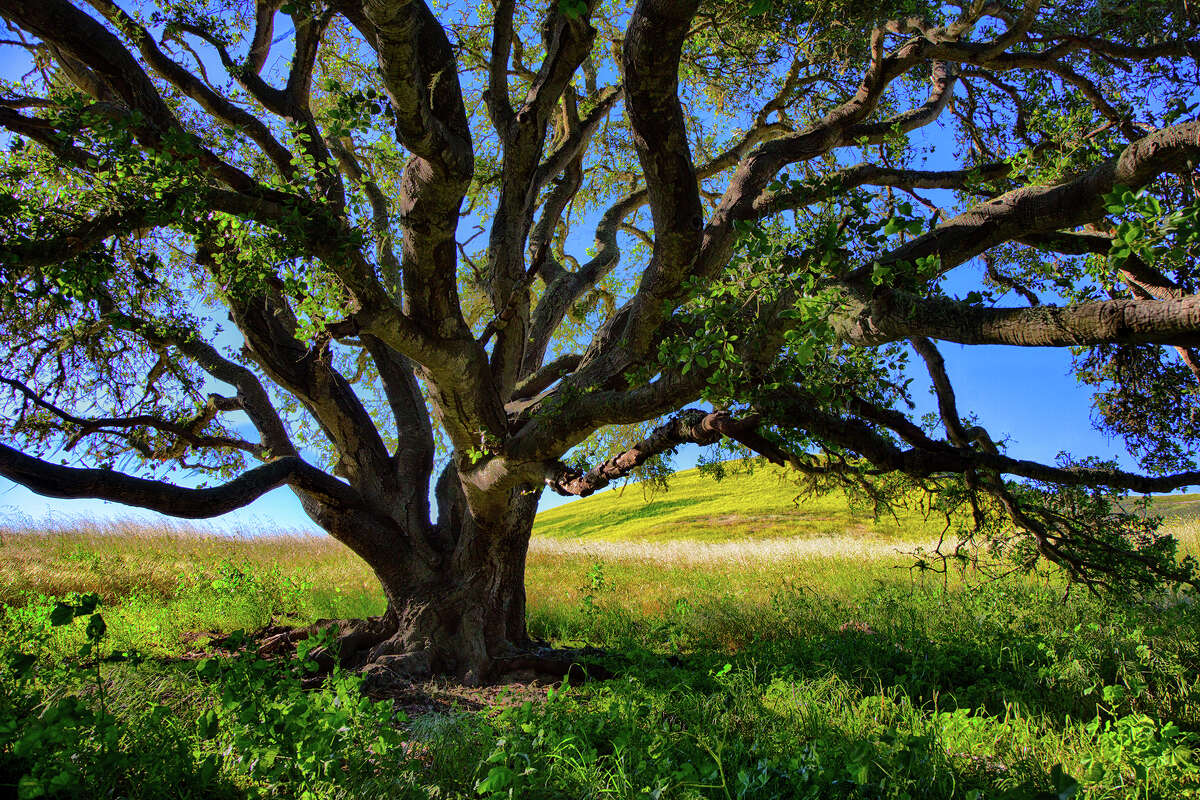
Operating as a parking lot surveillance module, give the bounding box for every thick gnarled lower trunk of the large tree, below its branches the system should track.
[324,479,538,684]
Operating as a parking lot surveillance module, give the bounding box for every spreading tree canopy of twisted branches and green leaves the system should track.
[0,0,1200,672]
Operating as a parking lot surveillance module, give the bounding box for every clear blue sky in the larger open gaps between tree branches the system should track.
[0,9,1152,529]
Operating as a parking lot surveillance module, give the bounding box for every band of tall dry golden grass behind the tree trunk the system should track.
[0,519,1200,613]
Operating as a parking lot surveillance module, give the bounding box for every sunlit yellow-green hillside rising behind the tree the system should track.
[534,468,1200,541]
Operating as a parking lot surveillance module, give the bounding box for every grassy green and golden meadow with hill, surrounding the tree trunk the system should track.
[0,465,1200,800]
